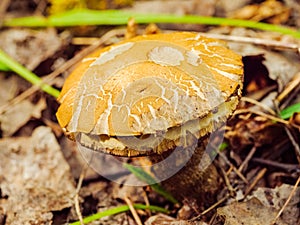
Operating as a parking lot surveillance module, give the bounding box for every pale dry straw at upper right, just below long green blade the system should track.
[200,33,300,54]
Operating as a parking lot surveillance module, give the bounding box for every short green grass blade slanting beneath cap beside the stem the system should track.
[123,163,178,204]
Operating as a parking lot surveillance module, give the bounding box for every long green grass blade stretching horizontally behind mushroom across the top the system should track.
[3,9,300,38]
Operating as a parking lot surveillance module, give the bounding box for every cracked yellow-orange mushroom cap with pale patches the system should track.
[56,32,243,156]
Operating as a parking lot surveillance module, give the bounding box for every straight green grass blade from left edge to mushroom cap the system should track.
[0,49,59,98]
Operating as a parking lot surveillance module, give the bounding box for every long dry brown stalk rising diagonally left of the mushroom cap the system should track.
[0,29,125,114]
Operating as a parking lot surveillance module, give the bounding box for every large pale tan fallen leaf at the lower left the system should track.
[0,127,75,225]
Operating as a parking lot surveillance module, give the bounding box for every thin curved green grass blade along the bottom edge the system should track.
[69,204,169,225]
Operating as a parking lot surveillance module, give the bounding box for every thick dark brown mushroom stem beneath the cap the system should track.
[150,137,221,208]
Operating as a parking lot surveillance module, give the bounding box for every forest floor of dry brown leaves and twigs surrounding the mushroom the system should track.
[0,0,300,225]
